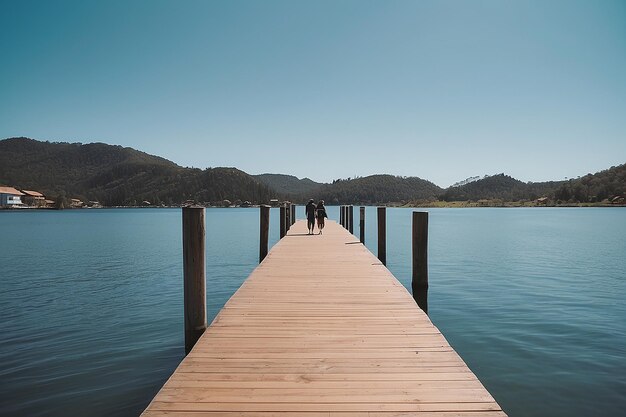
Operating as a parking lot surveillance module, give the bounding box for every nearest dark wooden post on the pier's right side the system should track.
[411,211,428,314]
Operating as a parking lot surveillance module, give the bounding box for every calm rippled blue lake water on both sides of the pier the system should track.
[0,207,626,417]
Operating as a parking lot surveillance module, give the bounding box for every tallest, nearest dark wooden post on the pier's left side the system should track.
[183,207,207,355]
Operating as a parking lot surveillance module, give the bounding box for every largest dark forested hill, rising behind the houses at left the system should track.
[0,138,274,206]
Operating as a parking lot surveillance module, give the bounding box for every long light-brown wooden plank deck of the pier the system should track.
[143,221,505,417]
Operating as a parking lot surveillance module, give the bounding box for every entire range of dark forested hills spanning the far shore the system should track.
[0,138,626,206]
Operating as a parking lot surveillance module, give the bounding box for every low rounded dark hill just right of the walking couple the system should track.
[315,175,443,204]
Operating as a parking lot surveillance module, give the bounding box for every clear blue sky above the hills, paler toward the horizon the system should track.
[0,0,626,186]
